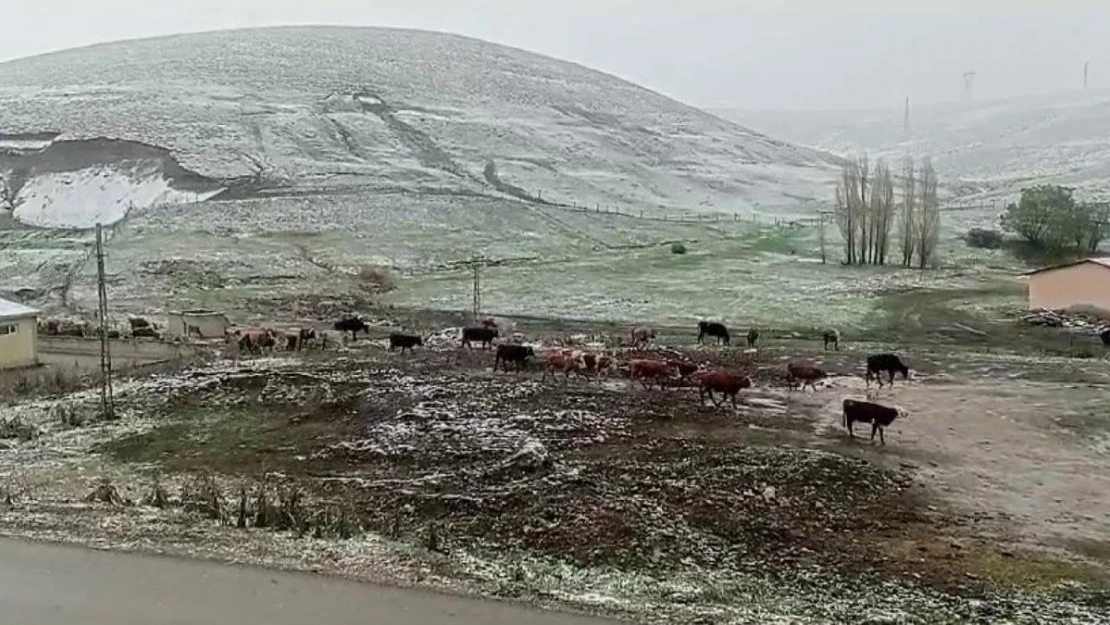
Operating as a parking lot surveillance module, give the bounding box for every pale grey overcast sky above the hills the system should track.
[0,0,1110,109]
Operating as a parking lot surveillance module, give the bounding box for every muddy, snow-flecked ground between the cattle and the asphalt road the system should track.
[0,332,1110,623]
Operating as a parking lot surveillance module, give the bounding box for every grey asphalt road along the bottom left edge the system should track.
[0,540,614,625]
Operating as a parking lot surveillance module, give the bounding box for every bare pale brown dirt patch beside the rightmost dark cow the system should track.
[819,379,1110,551]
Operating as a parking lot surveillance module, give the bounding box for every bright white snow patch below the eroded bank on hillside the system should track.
[14,164,219,229]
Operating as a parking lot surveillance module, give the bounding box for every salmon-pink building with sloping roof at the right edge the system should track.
[1022,258,1110,311]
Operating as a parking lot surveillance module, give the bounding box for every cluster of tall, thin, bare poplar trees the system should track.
[834,154,940,269]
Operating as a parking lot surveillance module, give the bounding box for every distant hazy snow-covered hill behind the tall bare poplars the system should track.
[716,91,1110,199]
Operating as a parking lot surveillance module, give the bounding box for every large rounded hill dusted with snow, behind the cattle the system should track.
[0,27,835,226]
